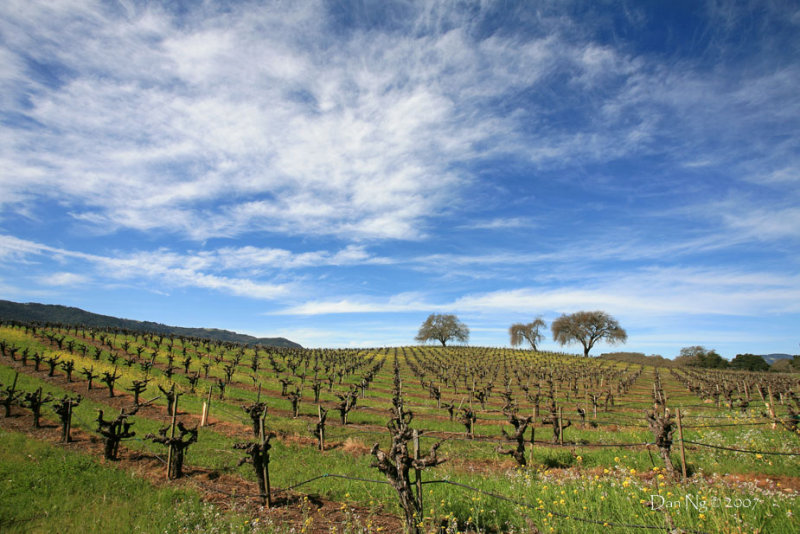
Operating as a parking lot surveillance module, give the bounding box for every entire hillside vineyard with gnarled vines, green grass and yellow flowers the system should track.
[0,323,800,533]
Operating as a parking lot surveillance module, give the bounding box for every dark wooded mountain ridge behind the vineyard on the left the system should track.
[0,300,303,349]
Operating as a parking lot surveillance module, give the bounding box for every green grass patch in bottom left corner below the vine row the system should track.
[0,430,272,533]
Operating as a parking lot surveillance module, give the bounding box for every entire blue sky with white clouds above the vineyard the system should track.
[0,0,800,358]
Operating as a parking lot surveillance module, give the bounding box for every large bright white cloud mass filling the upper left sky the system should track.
[2,0,540,239]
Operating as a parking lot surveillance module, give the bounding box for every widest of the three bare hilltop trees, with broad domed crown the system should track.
[550,311,628,357]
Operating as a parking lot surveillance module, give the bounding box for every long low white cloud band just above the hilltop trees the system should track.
[275,268,800,324]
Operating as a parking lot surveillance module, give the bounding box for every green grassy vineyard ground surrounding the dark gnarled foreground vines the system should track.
[0,327,800,533]
